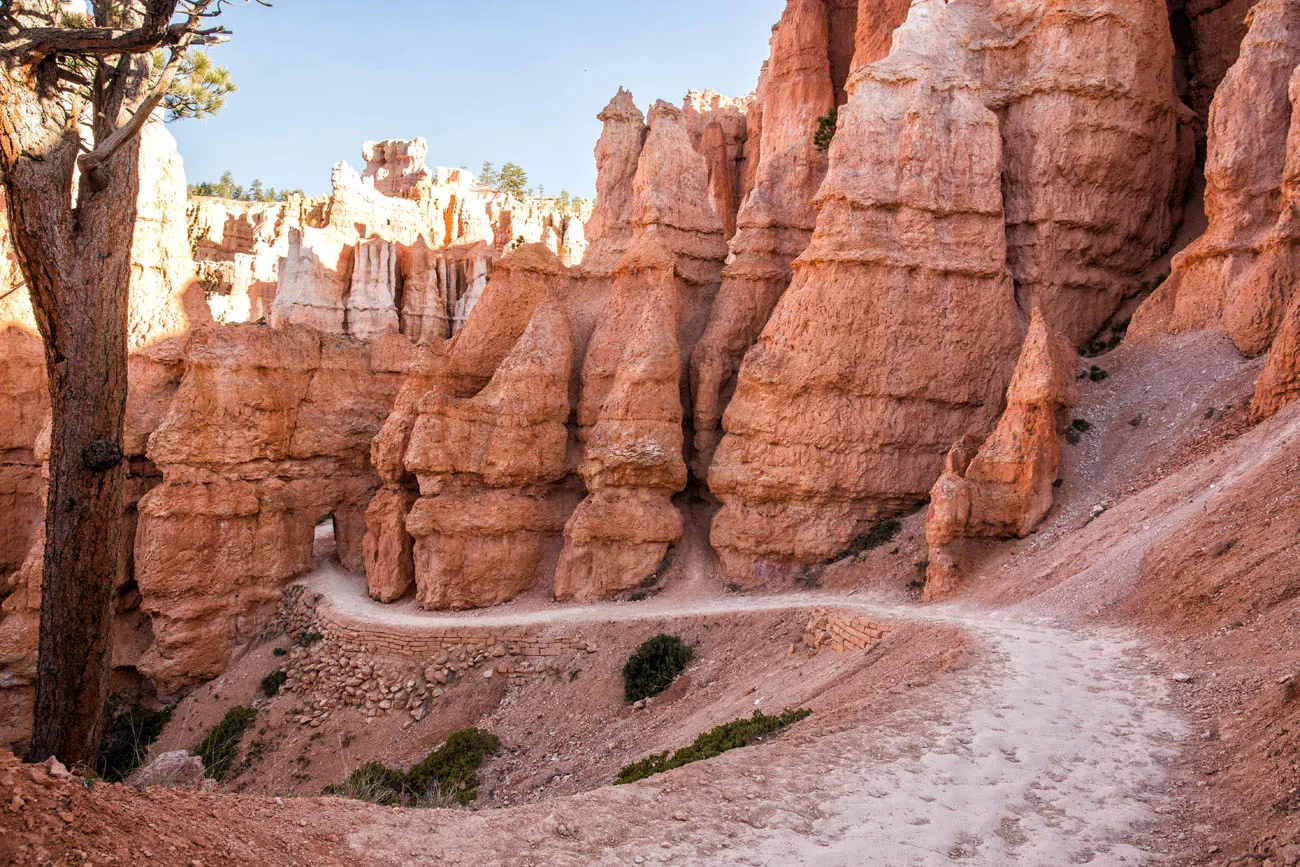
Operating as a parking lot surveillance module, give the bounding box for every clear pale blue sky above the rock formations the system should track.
[172,0,785,195]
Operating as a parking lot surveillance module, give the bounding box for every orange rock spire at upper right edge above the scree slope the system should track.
[1130,0,1300,356]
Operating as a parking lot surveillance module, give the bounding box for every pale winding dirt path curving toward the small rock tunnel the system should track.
[311,568,1184,867]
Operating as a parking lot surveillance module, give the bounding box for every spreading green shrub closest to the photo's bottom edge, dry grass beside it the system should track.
[324,728,501,807]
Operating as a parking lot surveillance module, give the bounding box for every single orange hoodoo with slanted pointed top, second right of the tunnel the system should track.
[404,298,573,608]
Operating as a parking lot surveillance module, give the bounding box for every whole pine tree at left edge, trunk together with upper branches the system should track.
[0,0,188,767]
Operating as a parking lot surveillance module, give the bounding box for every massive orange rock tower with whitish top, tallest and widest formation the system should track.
[701,0,1191,582]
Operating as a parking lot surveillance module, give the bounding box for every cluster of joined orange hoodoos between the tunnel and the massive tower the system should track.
[367,91,741,608]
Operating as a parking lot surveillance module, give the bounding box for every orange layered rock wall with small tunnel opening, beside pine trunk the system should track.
[135,325,410,689]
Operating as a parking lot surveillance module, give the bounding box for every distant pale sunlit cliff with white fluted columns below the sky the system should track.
[189,139,592,342]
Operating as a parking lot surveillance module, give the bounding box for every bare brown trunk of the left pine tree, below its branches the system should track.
[8,120,139,767]
